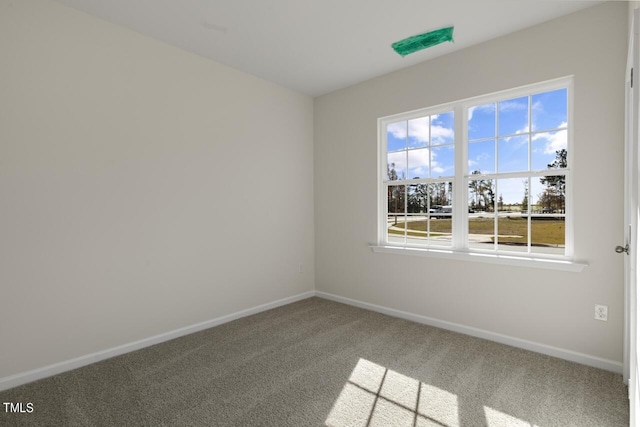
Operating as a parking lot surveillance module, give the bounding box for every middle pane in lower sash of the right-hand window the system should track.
[497,178,529,252]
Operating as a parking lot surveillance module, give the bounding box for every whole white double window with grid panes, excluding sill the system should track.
[379,78,572,259]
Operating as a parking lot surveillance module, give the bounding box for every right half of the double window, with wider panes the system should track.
[460,78,572,258]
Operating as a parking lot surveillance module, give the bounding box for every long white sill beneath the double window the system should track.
[370,246,588,273]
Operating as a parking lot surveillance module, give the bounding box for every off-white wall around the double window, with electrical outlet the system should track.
[314,2,627,364]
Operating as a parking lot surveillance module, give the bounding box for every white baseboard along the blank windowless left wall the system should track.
[0,291,315,391]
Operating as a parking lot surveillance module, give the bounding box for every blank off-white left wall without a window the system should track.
[0,0,314,378]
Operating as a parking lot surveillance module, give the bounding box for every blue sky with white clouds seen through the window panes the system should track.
[387,89,567,203]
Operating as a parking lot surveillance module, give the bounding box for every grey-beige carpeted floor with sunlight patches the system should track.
[0,298,629,427]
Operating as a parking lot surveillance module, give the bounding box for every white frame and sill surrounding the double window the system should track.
[371,76,587,271]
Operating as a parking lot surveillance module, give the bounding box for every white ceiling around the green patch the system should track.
[57,0,602,96]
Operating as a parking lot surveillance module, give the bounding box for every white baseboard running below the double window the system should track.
[315,291,622,374]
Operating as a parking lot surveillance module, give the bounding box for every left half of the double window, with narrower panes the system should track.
[386,111,455,246]
